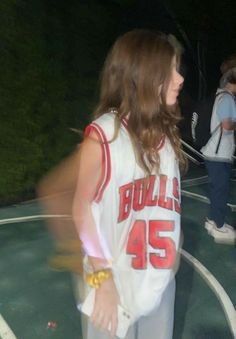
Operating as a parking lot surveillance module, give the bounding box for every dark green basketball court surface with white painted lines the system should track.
[0,168,236,339]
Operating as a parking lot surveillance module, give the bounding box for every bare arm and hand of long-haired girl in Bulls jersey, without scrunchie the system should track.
[73,133,119,336]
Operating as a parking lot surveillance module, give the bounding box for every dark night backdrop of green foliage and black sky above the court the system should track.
[0,0,236,206]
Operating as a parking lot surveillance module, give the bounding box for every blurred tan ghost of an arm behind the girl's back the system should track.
[37,148,79,243]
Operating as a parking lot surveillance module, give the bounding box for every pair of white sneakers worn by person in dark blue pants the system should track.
[205,219,236,244]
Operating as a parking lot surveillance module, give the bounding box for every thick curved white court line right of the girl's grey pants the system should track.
[181,249,236,339]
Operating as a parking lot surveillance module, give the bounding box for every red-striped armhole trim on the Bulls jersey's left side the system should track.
[84,123,111,203]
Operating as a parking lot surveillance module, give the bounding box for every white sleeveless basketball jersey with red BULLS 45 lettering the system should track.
[83,113,180,319]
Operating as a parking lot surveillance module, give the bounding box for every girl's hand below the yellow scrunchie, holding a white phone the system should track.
[90,277,119,338]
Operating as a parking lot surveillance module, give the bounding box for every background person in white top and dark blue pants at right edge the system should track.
[201,67,236,244]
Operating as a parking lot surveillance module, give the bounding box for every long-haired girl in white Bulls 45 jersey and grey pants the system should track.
[73,30,184,339]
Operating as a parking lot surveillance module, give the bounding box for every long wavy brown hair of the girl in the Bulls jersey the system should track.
[94,29,185,173]
